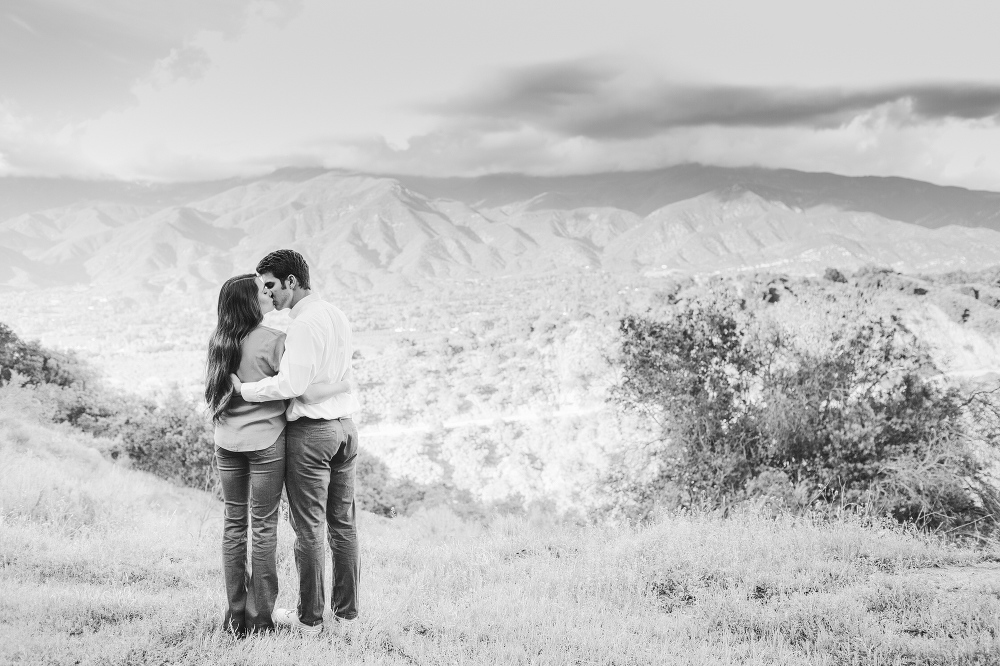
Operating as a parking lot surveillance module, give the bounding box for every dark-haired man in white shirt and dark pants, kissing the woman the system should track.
[233,250,360,634]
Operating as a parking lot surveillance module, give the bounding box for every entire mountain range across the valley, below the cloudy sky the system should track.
[0,165,1000,291]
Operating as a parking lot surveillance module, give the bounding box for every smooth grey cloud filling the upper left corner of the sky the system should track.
[0,0,302,125]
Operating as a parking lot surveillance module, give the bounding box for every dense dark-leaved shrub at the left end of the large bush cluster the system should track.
[615,302,765,505]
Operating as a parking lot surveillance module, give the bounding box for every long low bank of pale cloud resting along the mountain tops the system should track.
[11,103,1000,191]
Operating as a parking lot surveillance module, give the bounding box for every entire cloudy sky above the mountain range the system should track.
[0,0,1000,190]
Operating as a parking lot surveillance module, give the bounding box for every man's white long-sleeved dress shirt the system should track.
[240,294,361,421]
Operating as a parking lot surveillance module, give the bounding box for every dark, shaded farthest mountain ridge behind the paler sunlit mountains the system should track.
[0,163,1000,230]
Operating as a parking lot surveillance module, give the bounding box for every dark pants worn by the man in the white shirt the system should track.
[285,417,361,626]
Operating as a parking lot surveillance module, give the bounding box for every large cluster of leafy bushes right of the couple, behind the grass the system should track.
[611,290,1000,530]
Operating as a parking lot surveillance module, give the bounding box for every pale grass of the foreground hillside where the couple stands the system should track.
[0,416,1000,665]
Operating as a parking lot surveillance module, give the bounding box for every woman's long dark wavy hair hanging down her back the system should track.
[205,273,264,423]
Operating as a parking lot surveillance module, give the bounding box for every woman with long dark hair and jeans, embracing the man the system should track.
[205,274,349,636]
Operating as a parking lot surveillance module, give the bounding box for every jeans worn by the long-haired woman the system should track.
[215,433,285,634]
